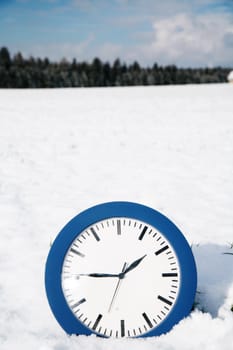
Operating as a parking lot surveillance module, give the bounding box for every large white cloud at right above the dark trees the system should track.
[122,13,233,66]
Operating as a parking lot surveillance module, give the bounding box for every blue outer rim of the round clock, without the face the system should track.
[45,201,197,337]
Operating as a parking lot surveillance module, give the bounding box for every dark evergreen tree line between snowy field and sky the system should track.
[0,47,232,88]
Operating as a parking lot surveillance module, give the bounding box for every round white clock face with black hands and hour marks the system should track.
[61,217,181,337]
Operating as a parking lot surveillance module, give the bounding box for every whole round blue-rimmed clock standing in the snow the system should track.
[45,202,197,338]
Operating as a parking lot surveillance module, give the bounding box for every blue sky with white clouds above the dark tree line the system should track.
[0,0,233,67]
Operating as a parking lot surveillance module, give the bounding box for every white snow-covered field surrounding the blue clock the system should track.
[0,84,233,350]
